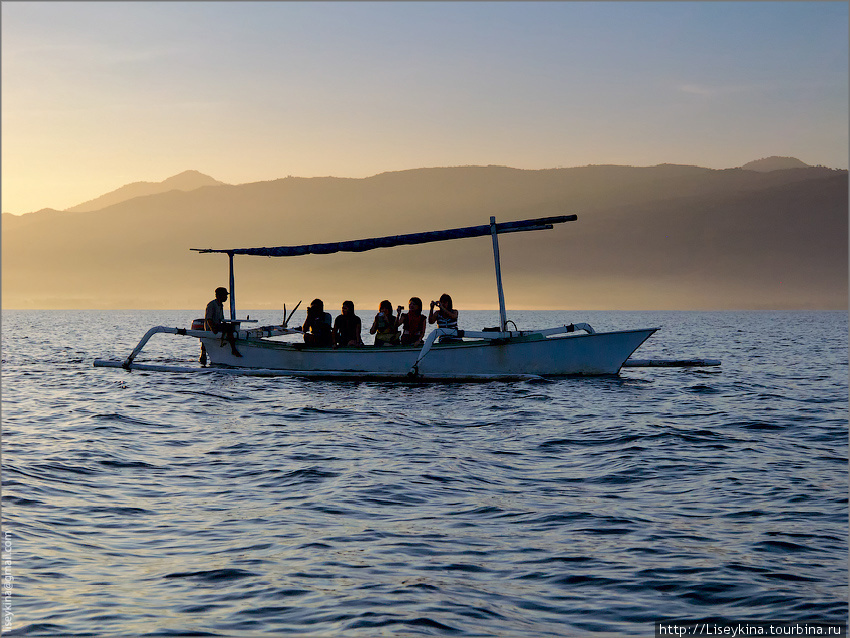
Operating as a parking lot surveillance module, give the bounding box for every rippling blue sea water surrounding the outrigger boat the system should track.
[2,311,848,638]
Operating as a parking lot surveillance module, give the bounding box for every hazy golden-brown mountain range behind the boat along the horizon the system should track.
[2,158,848,316]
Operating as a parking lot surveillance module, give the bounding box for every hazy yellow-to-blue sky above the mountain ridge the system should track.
[0,2,848,214]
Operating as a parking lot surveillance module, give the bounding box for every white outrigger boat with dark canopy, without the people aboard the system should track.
[94,215,708,381]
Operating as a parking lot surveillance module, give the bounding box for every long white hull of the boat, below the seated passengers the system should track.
[201,328,657,380]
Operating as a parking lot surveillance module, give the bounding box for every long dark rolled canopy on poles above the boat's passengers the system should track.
[191,215,577,257]
